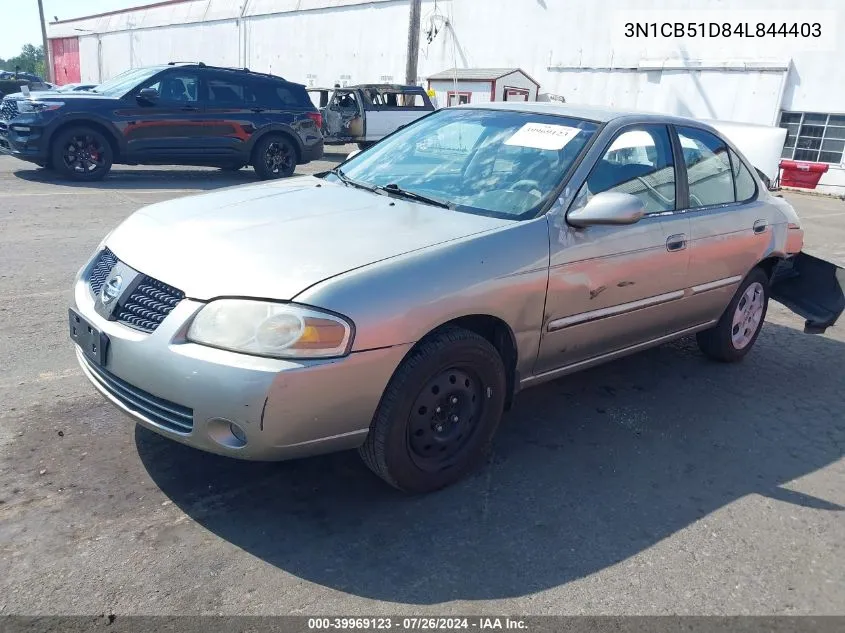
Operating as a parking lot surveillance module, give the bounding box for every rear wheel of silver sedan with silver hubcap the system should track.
[696,268,769,363]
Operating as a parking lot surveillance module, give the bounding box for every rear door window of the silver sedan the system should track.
[678,127,736,209]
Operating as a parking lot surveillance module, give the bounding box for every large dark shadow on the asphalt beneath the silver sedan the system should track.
[135,323,845,604]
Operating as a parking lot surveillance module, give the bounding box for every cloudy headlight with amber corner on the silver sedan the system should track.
[188,299,352,358]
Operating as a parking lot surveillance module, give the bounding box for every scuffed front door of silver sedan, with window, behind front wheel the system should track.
[535,125,689,374]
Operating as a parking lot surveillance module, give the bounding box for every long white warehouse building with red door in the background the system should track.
[48,0,845,194]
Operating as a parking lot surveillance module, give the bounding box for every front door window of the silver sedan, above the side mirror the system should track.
[575,125,675,213]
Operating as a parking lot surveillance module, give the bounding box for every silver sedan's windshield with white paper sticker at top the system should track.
[332,108,598,219]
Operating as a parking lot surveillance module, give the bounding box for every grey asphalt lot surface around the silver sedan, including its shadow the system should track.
[0,153,845,615]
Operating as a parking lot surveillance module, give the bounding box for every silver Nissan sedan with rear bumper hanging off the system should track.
[69,103,845,492]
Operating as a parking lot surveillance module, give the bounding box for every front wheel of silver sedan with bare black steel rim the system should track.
[358,328,507,493]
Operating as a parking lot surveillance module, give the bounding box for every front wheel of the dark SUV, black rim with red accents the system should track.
[49,126,114,182]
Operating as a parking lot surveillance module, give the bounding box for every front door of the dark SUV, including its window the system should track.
[118,69,209,162]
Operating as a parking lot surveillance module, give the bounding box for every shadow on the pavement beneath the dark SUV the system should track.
[13,167,268,191]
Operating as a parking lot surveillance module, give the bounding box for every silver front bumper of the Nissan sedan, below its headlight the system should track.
[73,262,410,461]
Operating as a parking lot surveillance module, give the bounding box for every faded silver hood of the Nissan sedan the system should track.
[106,176,512,300]
